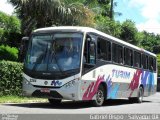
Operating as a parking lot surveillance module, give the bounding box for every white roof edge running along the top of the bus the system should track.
[34,26,156,57]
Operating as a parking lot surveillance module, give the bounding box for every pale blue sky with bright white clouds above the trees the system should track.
[0,0,160,34]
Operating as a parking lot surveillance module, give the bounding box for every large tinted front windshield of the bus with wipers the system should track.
[24,32,83,76]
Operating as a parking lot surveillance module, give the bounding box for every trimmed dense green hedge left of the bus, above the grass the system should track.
[0,61,23,96]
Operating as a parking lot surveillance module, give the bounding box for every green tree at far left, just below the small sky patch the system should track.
[0,12,22,47]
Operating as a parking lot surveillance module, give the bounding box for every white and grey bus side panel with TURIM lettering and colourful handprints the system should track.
[80,64,156,100]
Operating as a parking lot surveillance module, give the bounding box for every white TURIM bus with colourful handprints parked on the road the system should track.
[23,26,157,106]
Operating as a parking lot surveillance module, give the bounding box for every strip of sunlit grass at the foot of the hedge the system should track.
[0,96,47,103]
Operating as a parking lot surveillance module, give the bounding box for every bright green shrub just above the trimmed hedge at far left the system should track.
[0,45,18,61]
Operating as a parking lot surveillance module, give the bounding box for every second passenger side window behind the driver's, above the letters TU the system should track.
[112,43,123,64]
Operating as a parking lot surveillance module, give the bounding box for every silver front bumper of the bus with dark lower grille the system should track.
[23,79,80,101]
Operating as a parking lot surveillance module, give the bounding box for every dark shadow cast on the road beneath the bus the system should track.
[5,99,151,109]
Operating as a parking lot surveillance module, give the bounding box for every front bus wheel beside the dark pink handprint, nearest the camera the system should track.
[93,85,105,107]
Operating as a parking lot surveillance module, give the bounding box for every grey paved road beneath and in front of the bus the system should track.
[0,93,160,114]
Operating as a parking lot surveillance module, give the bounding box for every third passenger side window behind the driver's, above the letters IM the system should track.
[124,48,133,66]
